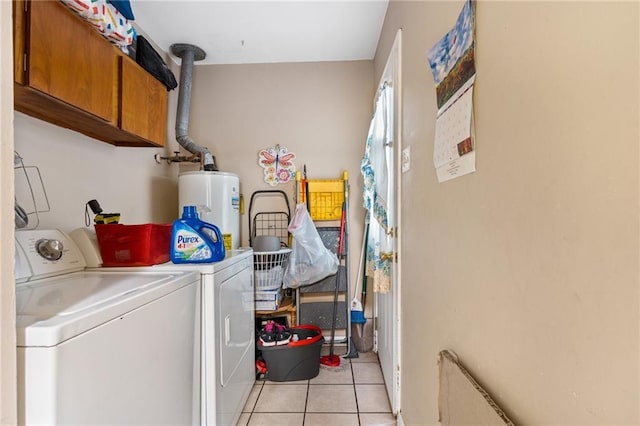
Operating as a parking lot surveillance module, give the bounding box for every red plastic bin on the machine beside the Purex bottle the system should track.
[95,223,172,266]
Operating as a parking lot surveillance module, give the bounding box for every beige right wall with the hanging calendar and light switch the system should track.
[375,1,640,425]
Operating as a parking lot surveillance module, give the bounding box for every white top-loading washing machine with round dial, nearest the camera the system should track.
[16,230,200,425]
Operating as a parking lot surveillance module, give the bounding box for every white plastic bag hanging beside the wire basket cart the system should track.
[282,203,339,288]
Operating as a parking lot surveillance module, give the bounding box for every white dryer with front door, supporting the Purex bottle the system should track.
[74,230,256,426]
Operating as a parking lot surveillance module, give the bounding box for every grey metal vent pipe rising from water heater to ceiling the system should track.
[170,43,218,171]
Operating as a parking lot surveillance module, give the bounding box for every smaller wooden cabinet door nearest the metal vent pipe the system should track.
[120,57,167,146]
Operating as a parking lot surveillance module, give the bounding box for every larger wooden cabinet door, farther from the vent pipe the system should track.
[27,1,118,125]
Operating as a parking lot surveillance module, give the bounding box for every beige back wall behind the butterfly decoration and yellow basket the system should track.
[182,61,374,286]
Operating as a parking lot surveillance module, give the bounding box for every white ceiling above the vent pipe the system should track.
[131,0,388,65]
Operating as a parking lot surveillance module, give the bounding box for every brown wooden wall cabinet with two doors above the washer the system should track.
[13,0,167,147]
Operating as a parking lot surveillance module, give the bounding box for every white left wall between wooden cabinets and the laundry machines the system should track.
[15,113,178,231]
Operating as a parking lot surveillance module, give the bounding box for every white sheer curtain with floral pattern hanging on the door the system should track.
[360,83,393,293]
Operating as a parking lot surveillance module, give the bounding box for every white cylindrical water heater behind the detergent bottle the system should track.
[178,171,240,250]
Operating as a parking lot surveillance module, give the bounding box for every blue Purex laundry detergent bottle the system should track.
[171,206,225,263]
